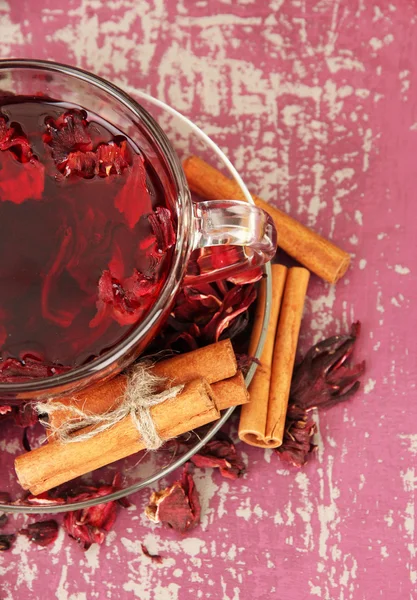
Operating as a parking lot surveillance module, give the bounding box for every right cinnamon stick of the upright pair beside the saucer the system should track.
[267,267,310,446]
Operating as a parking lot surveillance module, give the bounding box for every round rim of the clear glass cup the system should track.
[0,59,193,397]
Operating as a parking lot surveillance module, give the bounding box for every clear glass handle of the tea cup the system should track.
[184,200,277,286]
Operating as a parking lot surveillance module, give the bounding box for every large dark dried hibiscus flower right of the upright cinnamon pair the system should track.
[276,322,365,467]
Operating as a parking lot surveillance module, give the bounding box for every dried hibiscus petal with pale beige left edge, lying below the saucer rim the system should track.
[145,467,201,533]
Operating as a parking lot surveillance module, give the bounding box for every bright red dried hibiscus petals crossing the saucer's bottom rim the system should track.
[63,474,126,550]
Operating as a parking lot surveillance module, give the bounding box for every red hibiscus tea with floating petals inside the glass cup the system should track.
[0,96,175,382]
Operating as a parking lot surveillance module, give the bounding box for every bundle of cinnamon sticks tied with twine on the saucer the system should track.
[15,340,248,495]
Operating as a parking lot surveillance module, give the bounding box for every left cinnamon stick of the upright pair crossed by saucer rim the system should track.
[239,265,287,448]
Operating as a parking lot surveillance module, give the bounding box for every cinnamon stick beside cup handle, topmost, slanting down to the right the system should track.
[183,156,350,283]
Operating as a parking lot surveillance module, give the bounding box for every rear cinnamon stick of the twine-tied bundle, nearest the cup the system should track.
[48,339,237,439]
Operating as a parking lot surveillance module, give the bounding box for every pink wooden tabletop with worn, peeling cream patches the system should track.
[0,0,417,600]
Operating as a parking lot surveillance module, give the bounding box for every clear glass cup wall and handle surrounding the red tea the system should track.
[0,60,276,403]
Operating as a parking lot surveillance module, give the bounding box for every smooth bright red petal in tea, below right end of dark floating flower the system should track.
[115,154,152,229]
